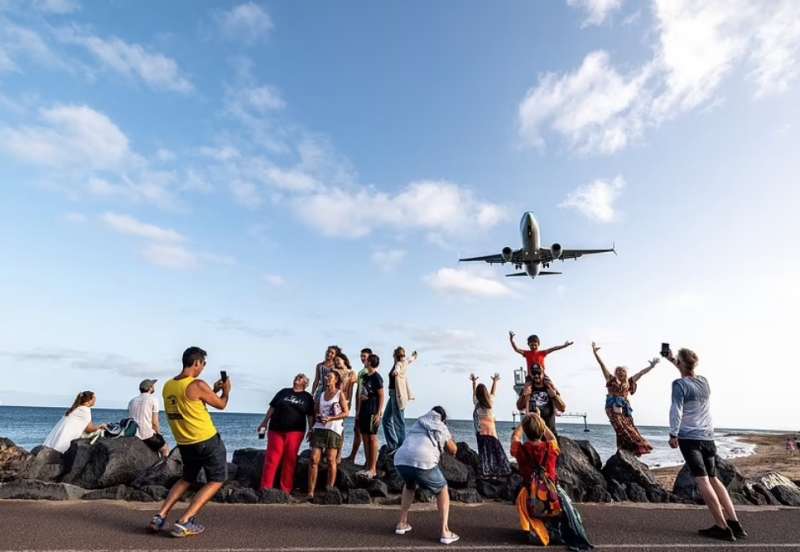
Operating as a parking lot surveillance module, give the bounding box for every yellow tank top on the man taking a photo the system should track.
[162,377,217,445]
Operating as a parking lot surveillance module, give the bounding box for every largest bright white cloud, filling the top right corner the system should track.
[518,0,800,154]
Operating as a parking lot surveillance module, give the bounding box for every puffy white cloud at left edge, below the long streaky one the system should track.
[0,105,131,169]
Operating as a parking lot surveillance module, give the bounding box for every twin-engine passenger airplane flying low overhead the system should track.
[459,211,617,278]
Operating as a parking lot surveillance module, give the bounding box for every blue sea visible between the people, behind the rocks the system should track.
[0,406,774,468]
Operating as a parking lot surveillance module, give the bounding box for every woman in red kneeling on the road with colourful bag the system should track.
[511,413,592,550]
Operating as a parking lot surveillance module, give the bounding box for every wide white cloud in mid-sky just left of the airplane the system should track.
[294,180,504,238]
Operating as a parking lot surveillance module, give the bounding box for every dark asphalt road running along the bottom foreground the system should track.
[0,500,800,552]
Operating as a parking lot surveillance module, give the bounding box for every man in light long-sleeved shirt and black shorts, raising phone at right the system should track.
[665,349,747,541]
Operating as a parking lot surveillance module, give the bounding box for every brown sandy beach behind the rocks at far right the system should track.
[653,433,800,489]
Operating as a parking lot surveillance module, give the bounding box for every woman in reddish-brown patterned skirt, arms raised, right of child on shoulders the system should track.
[592,341,658,456]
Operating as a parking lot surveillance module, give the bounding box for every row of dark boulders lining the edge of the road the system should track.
[0,437,800,506]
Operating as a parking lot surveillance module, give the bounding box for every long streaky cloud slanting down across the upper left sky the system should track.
[57,28,194,93]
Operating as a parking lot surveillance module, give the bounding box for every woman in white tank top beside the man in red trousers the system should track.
[308,371,350,498]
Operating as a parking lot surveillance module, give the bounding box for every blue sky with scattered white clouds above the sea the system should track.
[0,0,800,428]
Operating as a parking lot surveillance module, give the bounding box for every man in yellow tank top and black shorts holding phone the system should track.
[148,347,231,537]
